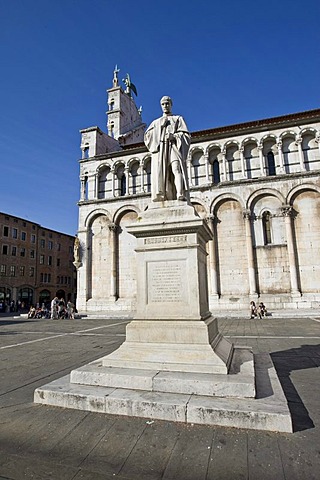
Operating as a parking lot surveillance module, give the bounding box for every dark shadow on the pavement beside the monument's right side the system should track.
[271,345,320,432]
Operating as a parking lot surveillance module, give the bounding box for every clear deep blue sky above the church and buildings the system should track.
[0,0,320,235]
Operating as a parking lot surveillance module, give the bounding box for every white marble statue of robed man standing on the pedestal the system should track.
[144,96,190,202]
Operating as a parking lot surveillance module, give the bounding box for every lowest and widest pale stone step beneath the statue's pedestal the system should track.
[34,354,292,432]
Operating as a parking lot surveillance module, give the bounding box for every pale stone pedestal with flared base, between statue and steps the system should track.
[102,201,233,376]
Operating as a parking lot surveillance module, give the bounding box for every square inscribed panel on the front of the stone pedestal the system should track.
[147,259,187,303]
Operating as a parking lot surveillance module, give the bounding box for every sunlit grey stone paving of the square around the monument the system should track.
[0,312,320,480]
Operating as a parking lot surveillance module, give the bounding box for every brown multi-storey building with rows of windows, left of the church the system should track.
[0,213,77,311]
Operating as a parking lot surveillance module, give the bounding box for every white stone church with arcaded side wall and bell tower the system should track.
[76,70,320,316]
